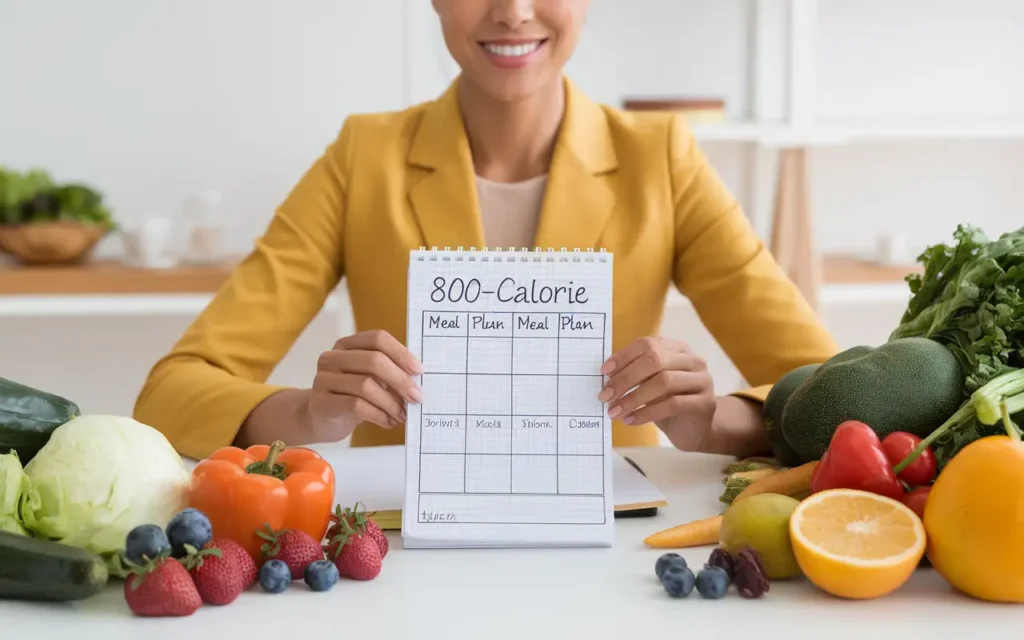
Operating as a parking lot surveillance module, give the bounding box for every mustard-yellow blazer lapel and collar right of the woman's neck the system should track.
[534,80,617,251]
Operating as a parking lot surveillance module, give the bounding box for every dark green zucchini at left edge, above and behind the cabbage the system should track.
[0,378,82,465]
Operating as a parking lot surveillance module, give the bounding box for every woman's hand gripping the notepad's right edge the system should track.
[598,337,717,451]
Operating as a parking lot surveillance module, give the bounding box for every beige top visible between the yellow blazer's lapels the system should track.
[476,175,548,249]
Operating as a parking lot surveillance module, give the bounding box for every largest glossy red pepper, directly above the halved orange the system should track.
[811,420,906,500]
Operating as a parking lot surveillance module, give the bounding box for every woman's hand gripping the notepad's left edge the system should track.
[309,331,423,441]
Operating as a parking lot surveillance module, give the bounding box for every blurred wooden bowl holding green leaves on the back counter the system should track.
[0,221,106,264]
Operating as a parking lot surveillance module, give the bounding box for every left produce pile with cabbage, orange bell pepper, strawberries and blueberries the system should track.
[0,378,388,616]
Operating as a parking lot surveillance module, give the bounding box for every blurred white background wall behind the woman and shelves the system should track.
[0,0,1024,413]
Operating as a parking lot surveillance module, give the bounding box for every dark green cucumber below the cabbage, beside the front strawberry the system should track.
[0,531,110,602]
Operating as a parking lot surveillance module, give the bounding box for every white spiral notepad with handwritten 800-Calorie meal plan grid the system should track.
[402,249,614,547]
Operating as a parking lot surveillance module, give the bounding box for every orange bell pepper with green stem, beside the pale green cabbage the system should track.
[188,441,335,562]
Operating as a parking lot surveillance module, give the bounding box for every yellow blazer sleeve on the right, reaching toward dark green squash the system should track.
[669,117,838,401]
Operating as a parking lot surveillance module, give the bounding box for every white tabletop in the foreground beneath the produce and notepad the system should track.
[0,449,1024,640]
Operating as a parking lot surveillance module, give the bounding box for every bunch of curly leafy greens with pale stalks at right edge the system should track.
[889,224,1024,467]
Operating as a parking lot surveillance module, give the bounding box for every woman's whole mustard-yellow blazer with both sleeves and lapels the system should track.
[134,80,837,458]
